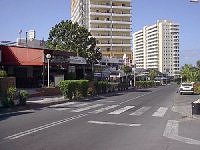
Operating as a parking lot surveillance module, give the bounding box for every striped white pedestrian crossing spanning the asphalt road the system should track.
[49,102,168,118]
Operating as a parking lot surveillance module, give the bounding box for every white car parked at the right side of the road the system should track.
[179,83,194,95]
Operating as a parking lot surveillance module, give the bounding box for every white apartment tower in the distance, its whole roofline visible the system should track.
[133,20,180,76]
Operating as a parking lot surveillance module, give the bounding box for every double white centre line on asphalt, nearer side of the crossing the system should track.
[4,114,87,140]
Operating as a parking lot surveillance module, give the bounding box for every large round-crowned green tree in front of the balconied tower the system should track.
[46,20,102,64]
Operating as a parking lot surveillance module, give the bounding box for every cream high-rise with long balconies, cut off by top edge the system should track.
[71,0,132,60]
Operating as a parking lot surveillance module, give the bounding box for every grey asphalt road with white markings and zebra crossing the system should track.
[0,84,200,150]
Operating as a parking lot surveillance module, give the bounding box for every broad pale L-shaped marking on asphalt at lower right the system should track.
[163,120,200,145]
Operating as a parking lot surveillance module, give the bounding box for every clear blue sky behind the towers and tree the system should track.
[0,0,200,65]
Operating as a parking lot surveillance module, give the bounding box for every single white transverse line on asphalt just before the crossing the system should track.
[88,121,141,127]
